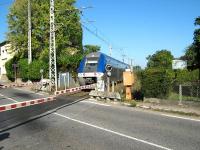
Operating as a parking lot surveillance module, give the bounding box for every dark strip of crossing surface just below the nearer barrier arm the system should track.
[0,94,88,132]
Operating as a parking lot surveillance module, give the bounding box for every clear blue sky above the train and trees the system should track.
[0,0,200,68]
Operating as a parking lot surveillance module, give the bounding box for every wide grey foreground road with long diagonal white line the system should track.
[0,97,200,150]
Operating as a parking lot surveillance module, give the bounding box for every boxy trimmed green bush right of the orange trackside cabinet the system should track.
[141,69,173,98]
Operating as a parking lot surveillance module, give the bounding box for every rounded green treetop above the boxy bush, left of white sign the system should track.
[147,50,173,69]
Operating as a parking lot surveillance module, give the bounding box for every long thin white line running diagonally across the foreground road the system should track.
[54,113,172,150]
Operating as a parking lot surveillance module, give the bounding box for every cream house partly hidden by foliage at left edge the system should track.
[0,41,14,81]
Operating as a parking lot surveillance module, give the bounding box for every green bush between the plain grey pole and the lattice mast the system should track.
[29,60,48,81]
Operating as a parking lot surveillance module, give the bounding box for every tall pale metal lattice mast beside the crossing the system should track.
[49,0,57,91]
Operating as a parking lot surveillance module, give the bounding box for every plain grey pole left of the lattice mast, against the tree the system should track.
[28,0,32,64]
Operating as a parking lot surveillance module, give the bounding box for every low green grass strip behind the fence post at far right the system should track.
[167,93,200,102]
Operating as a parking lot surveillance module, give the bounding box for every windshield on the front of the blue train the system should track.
[84,59,98,72]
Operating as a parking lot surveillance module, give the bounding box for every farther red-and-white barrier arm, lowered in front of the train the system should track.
[54,84,96,95]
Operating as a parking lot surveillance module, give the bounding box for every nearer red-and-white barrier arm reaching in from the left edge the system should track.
[0,96,55,112]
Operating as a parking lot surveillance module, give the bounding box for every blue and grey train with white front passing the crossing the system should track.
[77,52,130,91]
